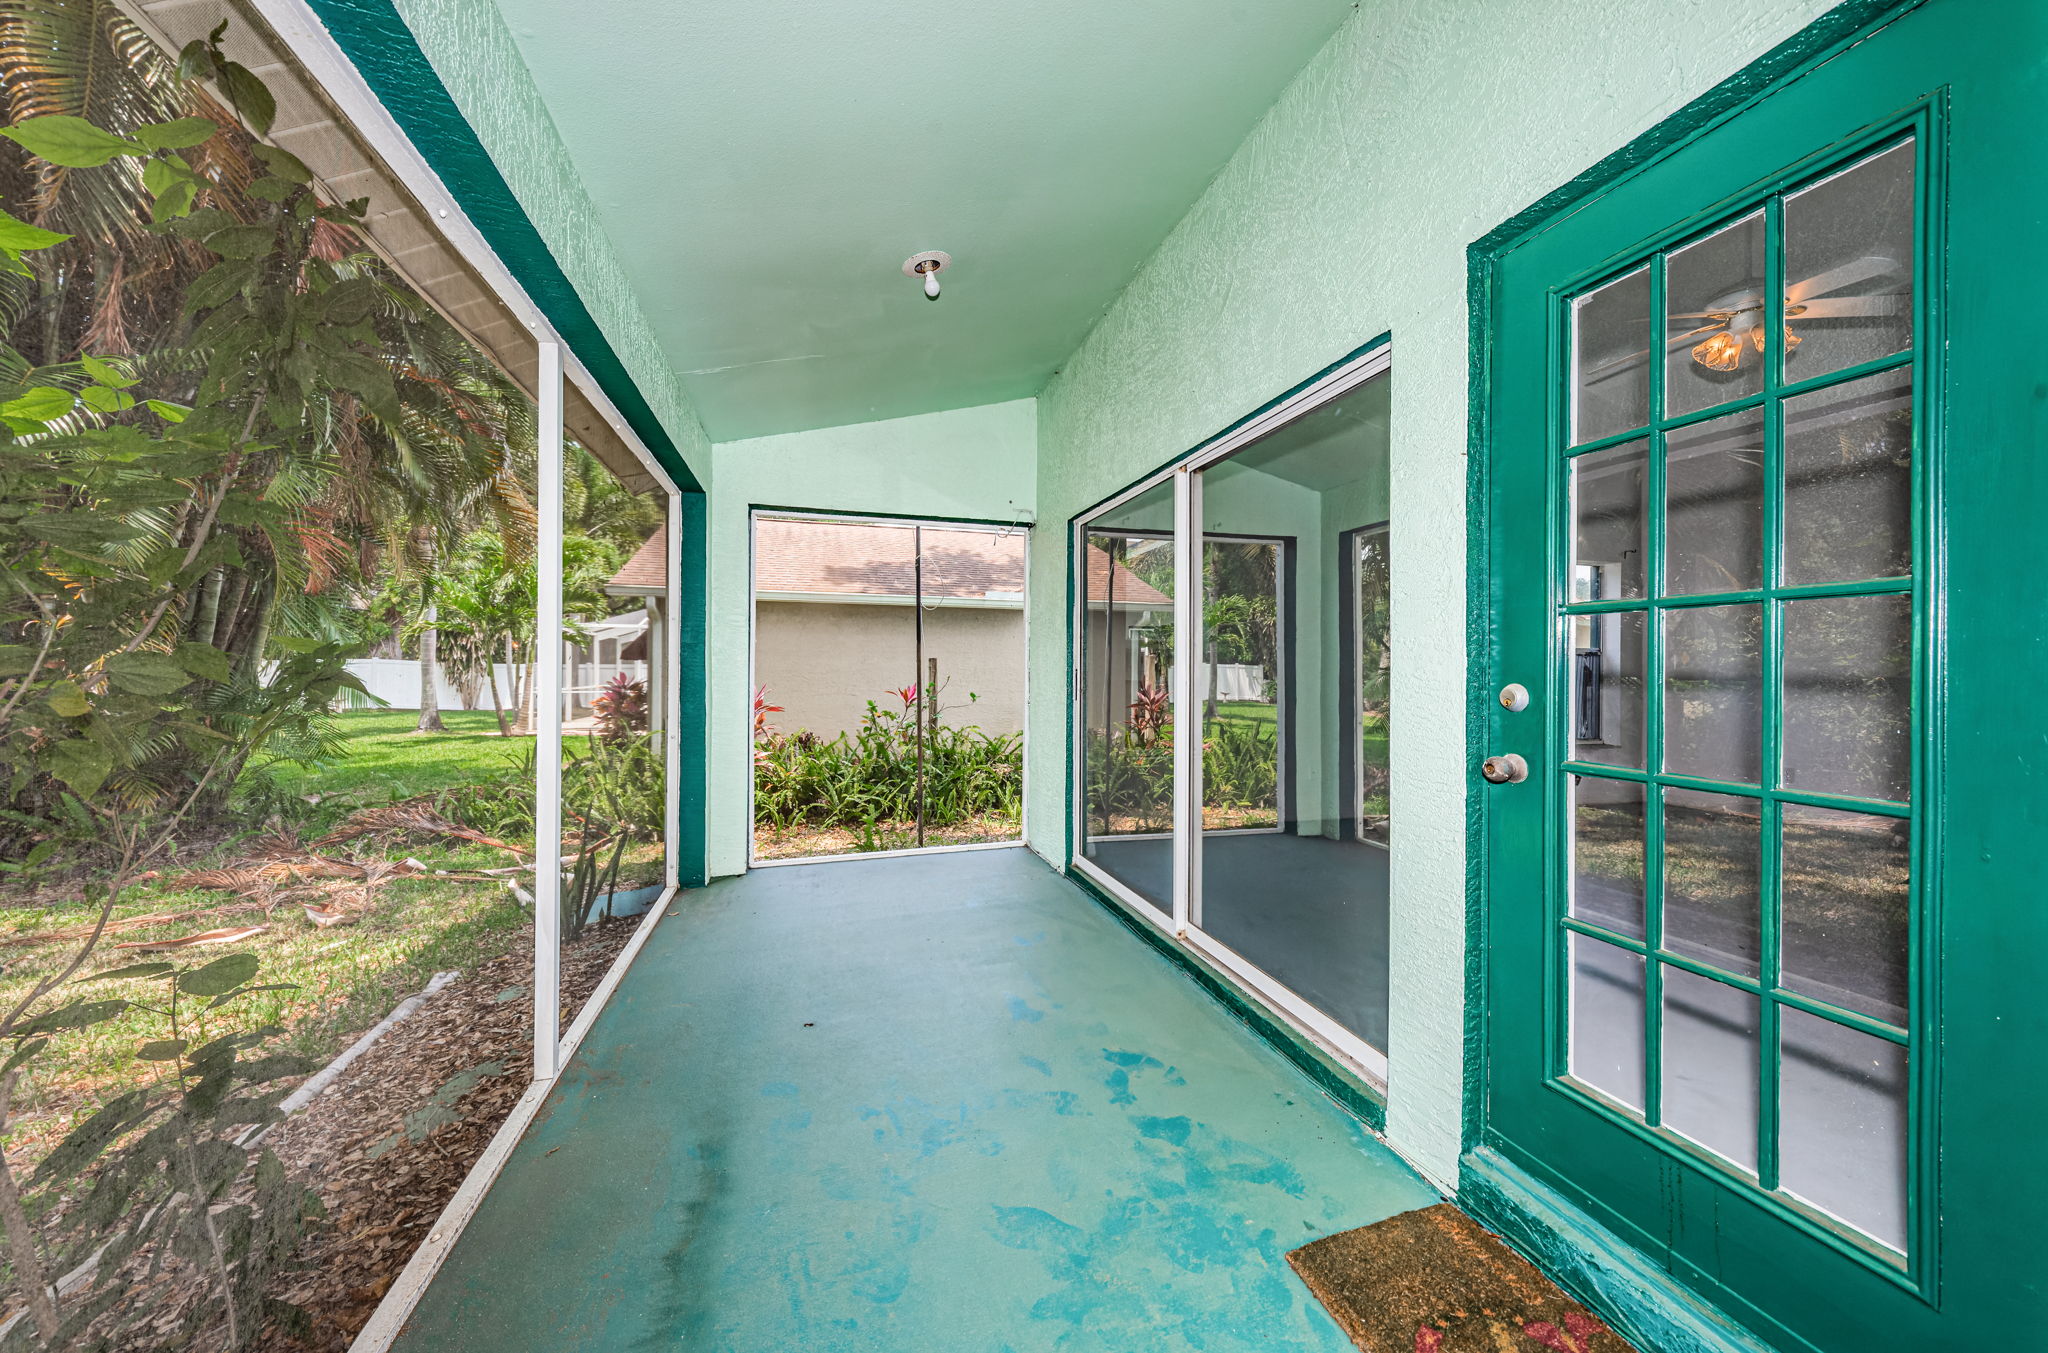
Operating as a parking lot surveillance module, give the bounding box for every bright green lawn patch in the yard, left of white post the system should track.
[270,710,532,821]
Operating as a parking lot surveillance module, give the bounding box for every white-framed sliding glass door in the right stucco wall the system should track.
[1075,350,1391,1077]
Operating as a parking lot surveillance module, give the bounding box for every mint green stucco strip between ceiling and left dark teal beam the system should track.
[393,0,713,487]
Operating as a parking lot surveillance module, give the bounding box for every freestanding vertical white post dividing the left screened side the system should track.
[532,342,561,1081]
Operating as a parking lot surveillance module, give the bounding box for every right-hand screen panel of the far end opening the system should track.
[918,526,1024,845]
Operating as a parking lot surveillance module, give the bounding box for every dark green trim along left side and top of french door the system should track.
[1460,0,1925,1161]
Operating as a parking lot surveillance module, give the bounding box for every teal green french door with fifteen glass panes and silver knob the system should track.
[1479,0,2048,1353]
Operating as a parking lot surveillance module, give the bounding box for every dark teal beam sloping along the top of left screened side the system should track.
[292,0,702,491]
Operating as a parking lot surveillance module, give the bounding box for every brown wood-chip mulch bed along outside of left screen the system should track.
[90,917,639,1353]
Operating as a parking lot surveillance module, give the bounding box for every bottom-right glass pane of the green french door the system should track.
[1778,1007,1907,1251]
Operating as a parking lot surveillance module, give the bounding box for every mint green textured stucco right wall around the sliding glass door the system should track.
[1028,0,1829,1183]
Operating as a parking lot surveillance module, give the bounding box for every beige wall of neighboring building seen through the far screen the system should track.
[754,602,1024,737]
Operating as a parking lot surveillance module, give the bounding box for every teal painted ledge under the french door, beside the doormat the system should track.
[1458,1148,1772,1353]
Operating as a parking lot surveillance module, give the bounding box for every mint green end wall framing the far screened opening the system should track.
[711,399,1040,876]
